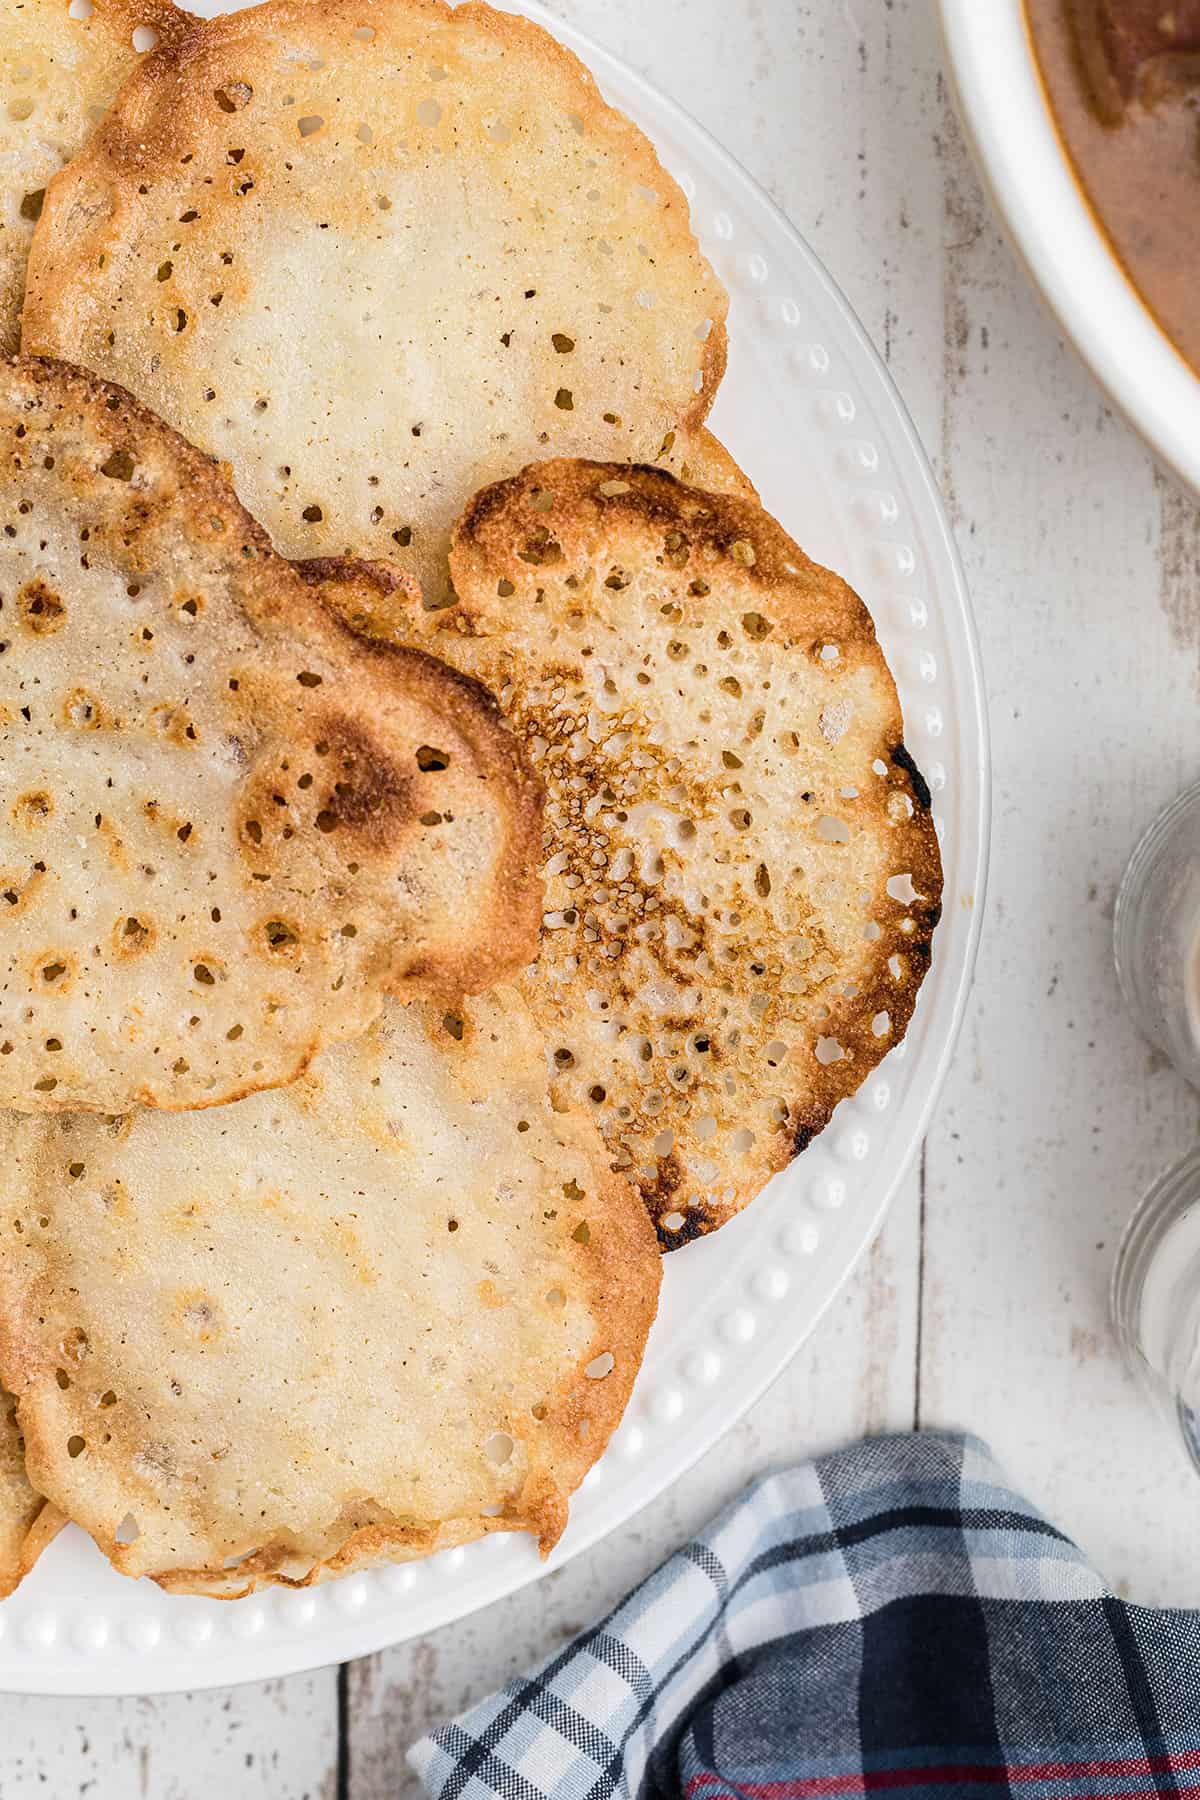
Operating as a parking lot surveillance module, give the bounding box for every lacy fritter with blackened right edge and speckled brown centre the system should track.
[444,461,941,1247]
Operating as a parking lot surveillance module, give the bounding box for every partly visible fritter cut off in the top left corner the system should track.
[0,0,187,356]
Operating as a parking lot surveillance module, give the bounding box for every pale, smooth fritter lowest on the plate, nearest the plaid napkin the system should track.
[0,990,660,1597]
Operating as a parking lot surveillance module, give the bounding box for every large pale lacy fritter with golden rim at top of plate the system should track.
[23,0,727,605]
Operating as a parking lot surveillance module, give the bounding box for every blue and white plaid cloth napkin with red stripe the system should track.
[410,1435,1200,1800]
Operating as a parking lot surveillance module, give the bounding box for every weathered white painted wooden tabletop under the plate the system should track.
[9,0,1200,1800]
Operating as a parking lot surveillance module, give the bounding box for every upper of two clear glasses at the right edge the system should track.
[1114,783,1200,1087]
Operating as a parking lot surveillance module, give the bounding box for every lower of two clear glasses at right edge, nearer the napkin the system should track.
[1112,1145,1200,1474]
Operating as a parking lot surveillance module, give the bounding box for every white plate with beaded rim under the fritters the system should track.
[0,0,988,1694]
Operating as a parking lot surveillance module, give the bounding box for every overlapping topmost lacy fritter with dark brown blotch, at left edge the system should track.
[0,362,540,1112]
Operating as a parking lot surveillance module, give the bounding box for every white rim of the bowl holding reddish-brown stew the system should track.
[941,0,1200,491]
